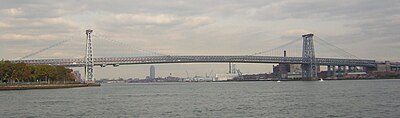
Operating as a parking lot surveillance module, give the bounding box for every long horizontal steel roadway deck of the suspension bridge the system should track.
[12,55,376,67]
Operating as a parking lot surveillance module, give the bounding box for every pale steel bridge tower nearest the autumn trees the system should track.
[85,29,94,83]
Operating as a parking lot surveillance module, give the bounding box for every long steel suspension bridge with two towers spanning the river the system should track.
[7,30,399,81]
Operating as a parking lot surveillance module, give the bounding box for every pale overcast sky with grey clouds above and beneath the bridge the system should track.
[0,0,400,78]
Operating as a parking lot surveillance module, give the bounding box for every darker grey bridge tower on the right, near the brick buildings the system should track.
[301,34,317,80]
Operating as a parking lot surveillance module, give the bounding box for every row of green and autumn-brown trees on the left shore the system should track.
[0,61,75,83]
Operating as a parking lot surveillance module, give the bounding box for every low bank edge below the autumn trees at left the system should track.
[0,83,100,91]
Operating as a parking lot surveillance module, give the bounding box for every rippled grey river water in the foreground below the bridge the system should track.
[0,80,400,118]
